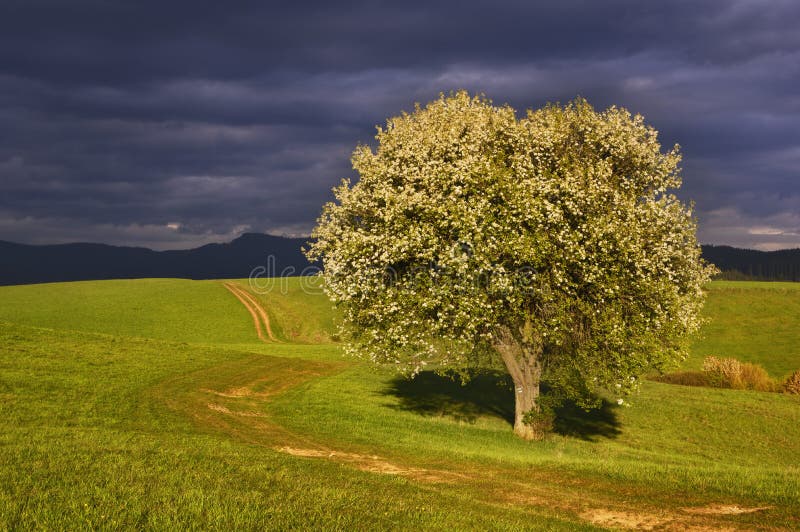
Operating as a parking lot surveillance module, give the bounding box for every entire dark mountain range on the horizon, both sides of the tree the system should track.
[0,233,800,285]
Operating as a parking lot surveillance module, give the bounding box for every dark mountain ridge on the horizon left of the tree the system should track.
[0,233,318,285]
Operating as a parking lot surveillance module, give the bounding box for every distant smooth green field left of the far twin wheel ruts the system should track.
[0,279,258,344]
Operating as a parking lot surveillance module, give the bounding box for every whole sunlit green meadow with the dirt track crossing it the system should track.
[0,279,800,530]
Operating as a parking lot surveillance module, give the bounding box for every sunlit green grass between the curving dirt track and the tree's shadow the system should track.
[269,367,800,504]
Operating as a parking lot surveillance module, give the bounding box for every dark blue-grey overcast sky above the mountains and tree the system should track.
[0,0,800,250]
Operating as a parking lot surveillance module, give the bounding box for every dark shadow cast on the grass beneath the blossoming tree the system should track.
[382,371,621,441]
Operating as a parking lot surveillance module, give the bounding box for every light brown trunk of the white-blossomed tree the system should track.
[494,328,545,440]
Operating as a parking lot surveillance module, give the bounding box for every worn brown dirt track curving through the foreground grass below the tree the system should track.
[151,355,770,531]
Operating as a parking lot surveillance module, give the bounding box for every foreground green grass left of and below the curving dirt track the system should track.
[0,324,576,529]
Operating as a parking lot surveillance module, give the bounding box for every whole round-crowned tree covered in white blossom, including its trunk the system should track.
[308,92,712,439]
